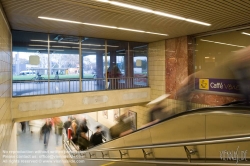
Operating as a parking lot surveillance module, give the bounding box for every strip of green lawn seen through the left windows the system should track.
[13,74,94,81]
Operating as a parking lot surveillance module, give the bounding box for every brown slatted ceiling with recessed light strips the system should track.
[0,0,250,42]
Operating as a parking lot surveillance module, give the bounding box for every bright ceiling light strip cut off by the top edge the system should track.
[96,0,211,26]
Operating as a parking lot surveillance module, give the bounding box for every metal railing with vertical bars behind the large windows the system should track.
[12,77,148,96]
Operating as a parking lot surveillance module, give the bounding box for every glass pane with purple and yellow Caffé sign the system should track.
[194,29,250,93]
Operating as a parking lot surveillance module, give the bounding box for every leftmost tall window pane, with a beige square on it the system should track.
[12,31,49,96]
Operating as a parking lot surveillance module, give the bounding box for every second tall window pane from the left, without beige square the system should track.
[50,34,80,93]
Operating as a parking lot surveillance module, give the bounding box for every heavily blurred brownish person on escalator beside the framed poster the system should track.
[109,114,133,139]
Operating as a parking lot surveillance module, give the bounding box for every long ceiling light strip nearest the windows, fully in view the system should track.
[38,16,168,36]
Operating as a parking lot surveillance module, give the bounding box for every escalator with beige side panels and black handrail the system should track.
[64,103,250,166]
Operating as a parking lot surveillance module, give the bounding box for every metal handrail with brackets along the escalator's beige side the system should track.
[61,132,250,166]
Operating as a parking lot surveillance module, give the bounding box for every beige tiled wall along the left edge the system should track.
[0,6,17,166]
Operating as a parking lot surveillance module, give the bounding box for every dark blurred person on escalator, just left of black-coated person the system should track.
[77,123,90,150]
